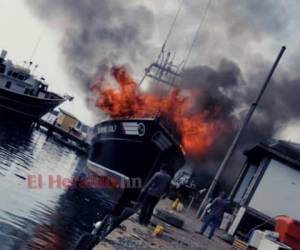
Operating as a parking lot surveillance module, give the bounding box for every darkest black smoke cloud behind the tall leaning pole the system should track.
[184,56,300,189]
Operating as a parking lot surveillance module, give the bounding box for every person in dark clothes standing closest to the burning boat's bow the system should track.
[139,164,171,225]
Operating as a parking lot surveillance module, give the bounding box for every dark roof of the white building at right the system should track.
[245,139,300,168]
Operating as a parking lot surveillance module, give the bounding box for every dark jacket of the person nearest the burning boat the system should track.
[143,170,171,198]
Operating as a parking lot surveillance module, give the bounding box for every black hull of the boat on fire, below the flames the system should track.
[87,119,185,200]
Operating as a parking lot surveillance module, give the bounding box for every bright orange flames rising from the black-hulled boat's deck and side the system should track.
[92,67,222,158]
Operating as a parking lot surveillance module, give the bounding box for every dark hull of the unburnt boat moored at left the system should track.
[0,88,65,122]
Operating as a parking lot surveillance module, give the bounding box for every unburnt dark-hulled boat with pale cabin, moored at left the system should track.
[0,50,71,121]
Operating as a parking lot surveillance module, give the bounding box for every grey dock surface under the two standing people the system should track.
[94,200,232,250]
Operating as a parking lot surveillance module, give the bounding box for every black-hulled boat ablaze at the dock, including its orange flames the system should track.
[88,44,219,202]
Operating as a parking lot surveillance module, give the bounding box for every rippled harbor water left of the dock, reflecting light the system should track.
[0,124,111,250]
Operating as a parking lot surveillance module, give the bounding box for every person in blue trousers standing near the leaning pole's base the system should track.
[200,192,229,239]
